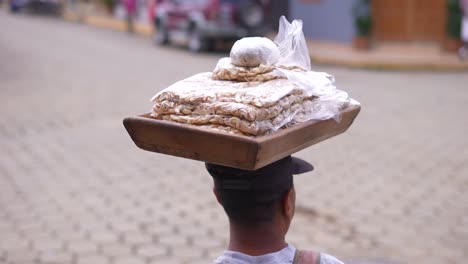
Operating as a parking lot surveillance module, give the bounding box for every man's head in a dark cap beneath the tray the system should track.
[206,156,313,229]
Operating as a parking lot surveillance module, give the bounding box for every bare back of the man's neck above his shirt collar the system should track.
[228,223,288,256]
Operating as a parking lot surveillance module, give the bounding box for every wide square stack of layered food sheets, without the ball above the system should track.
[152,72,316,135]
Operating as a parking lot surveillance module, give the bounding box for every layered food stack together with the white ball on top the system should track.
[152,37,349,136]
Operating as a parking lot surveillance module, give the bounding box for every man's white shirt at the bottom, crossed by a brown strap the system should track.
[214,245,344,264]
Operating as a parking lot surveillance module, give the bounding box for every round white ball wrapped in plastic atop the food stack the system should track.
[230,37,280,67]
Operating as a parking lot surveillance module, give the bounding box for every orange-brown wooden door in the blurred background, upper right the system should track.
[372,0,446,41]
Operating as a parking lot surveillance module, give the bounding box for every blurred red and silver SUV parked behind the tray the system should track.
[153,0,269,52]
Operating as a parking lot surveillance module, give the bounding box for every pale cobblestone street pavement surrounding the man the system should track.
[0,10,468,264]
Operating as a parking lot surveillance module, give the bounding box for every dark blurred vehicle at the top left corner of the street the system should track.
[10,0,63,14]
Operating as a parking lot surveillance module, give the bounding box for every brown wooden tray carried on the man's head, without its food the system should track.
[123,106,361,170]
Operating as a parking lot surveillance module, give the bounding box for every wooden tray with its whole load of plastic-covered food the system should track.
[124,17,361,170]
